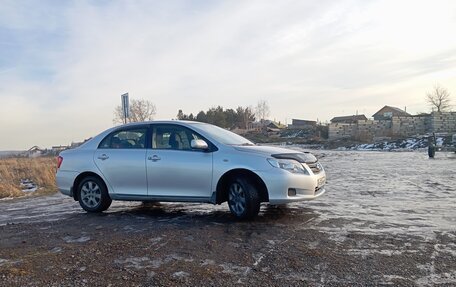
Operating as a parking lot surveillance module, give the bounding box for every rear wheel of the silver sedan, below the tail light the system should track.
[77,176,112,212]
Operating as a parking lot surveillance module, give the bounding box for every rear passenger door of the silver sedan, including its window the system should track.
[94,126,148,196]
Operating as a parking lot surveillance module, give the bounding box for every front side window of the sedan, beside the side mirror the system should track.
[152,125,201,150]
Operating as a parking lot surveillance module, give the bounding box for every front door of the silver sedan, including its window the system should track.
[146,124,212,201]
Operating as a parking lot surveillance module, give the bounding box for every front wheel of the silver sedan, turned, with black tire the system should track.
[227,176,260,219]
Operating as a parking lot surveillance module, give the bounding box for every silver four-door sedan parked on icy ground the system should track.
[56,121,326,219]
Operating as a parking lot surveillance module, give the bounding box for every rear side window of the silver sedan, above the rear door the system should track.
[98,129,147,149]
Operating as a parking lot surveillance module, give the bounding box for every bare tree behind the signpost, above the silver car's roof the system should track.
[112,99,157,123]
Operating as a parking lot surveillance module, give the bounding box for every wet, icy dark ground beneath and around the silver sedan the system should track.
[0,151,456,286]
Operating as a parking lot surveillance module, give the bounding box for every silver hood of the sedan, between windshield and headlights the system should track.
[234,146,317,163]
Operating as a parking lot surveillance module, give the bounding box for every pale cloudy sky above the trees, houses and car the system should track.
[0,0,456,150]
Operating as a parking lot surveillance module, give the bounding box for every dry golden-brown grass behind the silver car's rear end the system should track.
[0,157,57,198]
